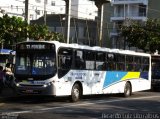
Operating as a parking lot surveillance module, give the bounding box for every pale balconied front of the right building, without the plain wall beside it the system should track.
[110,0,149,49]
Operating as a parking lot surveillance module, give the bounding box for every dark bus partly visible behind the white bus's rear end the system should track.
[151,55,160,91]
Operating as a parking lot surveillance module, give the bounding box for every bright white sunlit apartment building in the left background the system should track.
[0,0,97,20]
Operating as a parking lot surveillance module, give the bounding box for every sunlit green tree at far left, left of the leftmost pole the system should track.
[0,14,28,48]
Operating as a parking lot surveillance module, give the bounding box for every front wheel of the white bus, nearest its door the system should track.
[71,83,81,102]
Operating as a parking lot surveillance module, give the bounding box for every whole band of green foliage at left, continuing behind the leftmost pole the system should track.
[0,14,64,48]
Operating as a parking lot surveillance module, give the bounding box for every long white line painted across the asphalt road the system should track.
[0,96,159,114]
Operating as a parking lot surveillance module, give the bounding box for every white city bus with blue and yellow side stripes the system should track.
[14,41,151,102]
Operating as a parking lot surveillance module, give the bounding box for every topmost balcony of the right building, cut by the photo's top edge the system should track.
[111,0,148,5]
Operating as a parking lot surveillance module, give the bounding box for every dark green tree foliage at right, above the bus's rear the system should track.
[121,19,160,53]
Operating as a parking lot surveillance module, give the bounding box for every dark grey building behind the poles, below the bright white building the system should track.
[31,14,98,46]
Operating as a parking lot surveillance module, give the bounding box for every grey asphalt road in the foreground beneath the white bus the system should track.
[0,91,160,119]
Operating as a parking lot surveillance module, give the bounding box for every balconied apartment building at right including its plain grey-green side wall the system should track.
[105,0,160,50]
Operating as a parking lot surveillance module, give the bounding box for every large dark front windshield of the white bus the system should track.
[15,52,56,76]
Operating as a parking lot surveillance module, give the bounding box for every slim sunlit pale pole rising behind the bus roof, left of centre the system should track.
[64,0,71,43]
